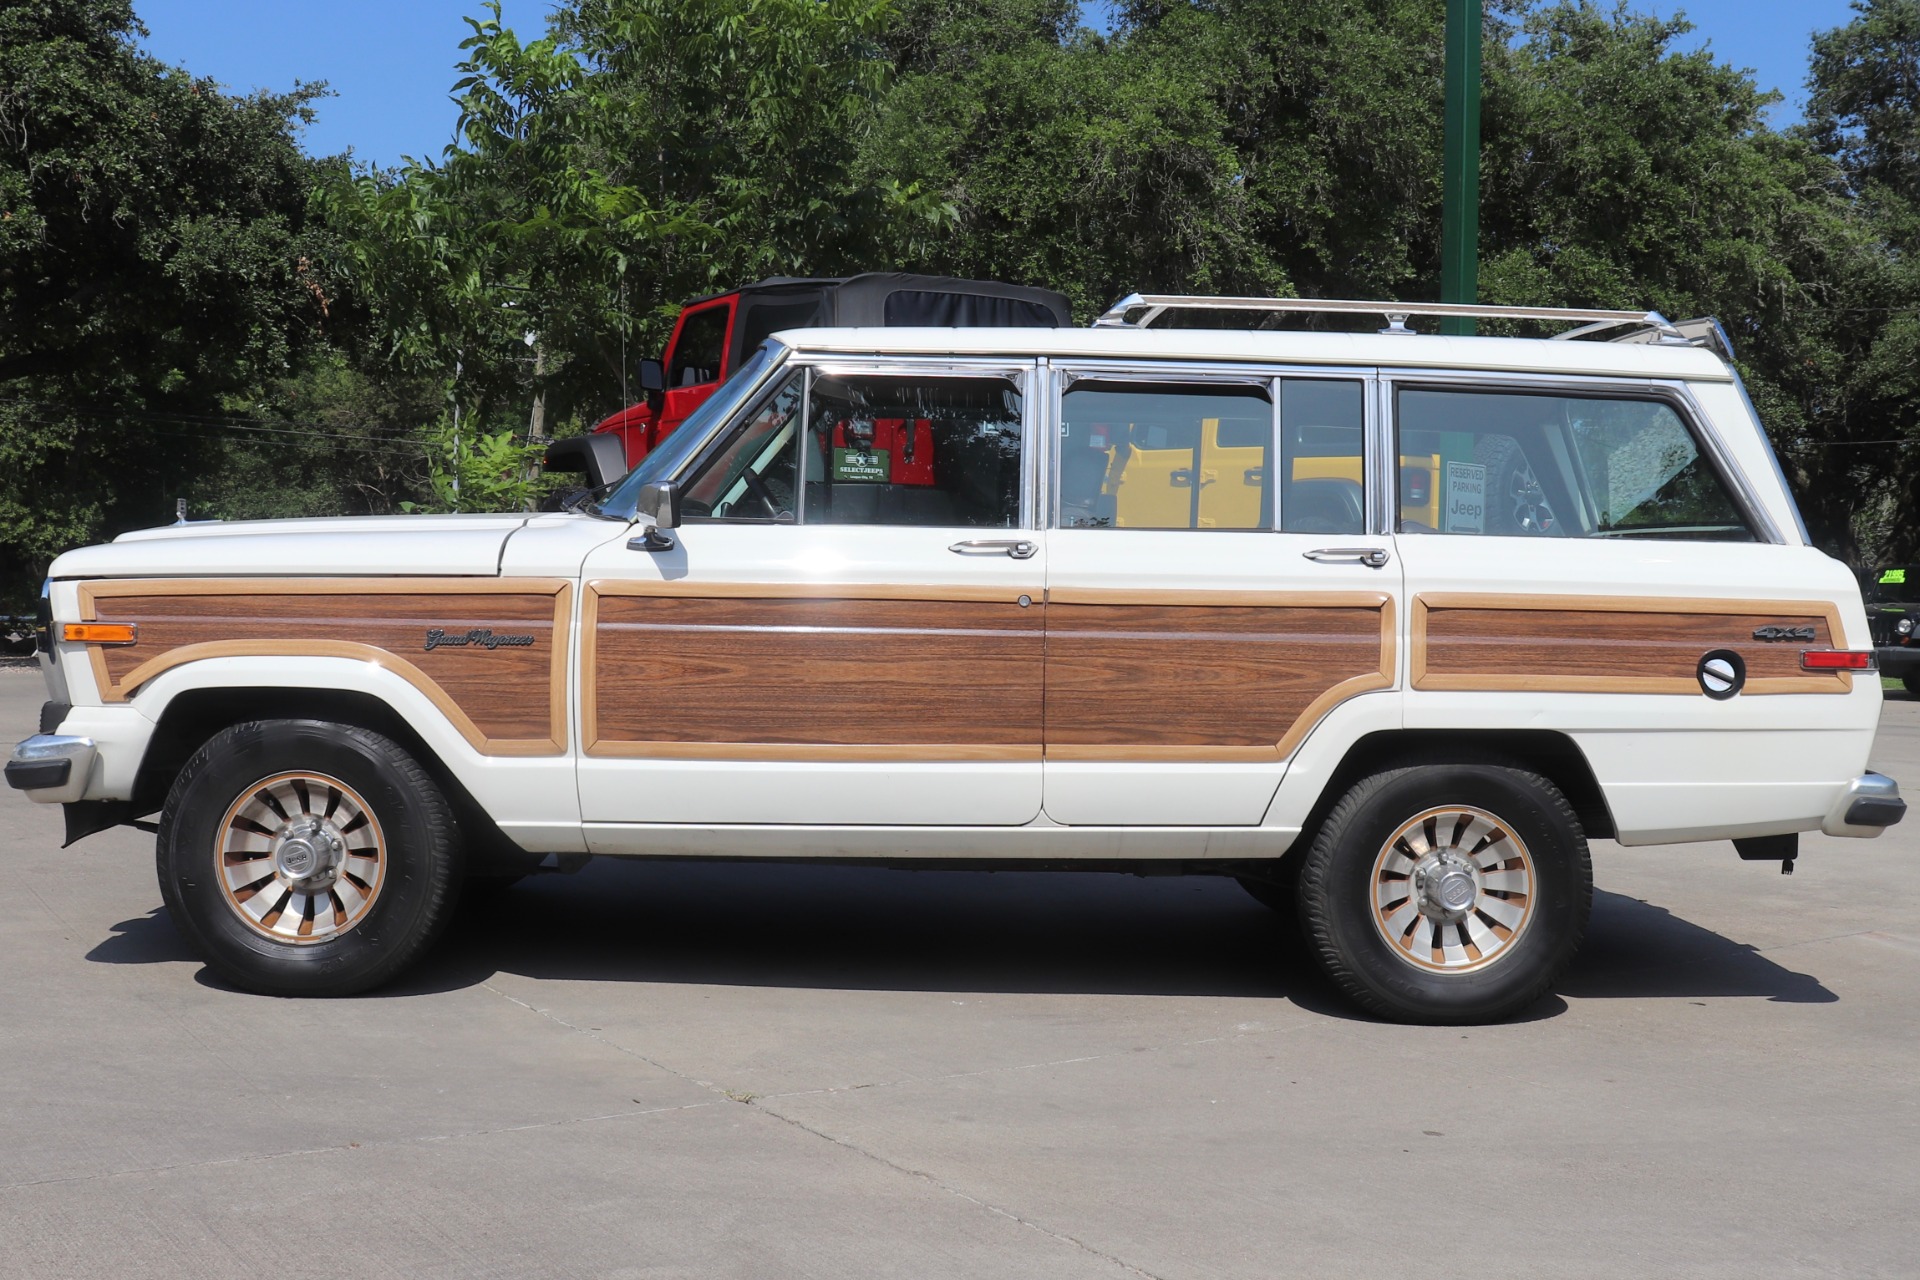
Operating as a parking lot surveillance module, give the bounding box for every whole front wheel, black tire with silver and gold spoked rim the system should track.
[156,720,459,996]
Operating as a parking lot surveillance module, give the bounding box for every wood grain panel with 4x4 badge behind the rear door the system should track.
[1409,595,1853,697]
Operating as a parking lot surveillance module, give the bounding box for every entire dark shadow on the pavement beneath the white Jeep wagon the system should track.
[74,858,1839,1021]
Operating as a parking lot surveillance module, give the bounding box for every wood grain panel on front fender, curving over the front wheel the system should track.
[81,580,572,756]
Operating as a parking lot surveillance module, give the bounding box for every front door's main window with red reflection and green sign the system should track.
[801,374,1021,530]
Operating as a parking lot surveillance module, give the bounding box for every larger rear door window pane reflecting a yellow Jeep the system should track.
[1058,382,1273,530]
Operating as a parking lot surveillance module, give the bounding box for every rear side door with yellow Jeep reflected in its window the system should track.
[1044,365,1400,827]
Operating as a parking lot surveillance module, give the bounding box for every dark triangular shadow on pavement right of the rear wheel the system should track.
[1557,890,1839,1004]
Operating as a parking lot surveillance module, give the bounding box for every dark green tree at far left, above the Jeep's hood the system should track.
[0,0,326,604]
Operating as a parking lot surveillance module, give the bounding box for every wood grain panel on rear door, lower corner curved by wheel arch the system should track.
[1046,591,1394,762]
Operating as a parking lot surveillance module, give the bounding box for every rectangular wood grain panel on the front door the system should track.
[582,583,1043,760]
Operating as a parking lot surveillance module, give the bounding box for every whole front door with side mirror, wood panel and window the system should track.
[580,361,1044,832]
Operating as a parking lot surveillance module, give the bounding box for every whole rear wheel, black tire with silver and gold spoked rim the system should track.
[1300,766,1594,1023]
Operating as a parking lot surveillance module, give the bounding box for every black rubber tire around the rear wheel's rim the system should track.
[1300,764,1594,1025]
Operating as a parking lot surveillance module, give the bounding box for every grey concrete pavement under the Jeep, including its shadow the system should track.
[0,670,1920,1280]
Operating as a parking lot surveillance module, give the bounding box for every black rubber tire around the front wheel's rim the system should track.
[156,720,461,996]
